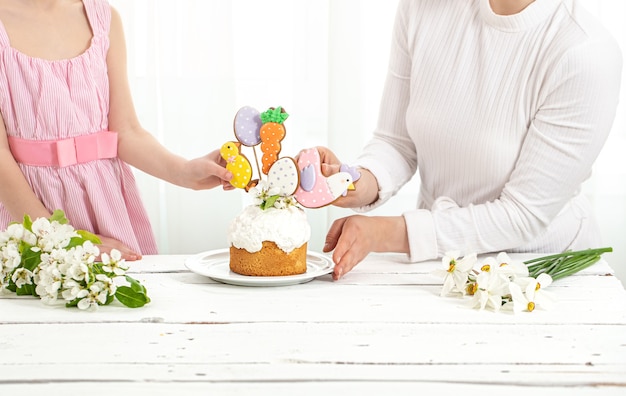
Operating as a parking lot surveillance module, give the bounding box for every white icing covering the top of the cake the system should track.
[228,205,311,253]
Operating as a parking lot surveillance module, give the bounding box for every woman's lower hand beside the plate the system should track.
[323,215,409,280]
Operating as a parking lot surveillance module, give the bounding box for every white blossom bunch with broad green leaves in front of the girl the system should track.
[0,210,150,309]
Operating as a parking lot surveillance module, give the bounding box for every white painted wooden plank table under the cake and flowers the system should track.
[0,255,626,396]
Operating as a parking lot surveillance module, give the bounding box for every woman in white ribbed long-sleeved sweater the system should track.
[320,0,622,279]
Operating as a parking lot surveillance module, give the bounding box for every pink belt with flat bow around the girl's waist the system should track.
[9,131,117,168]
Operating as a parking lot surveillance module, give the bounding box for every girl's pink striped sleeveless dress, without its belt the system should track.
[0,0,157,254]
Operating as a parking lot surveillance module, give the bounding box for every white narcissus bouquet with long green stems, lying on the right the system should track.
[433,247,613,313]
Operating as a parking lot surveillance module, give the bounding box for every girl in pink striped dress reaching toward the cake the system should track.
[0,0,232,260]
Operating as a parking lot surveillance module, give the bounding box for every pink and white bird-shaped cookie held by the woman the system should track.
[295,148,354,208]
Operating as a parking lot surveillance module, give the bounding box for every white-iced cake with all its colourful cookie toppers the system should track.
[220,106,359,276]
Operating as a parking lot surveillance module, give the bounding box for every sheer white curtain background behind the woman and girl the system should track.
[110,0,626,284]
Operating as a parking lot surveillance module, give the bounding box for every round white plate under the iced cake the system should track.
[185,249,334,286]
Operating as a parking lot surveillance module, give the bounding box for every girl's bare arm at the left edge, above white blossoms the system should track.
[0,115,51,221]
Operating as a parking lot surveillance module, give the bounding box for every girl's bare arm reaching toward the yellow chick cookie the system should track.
[107,8,232,189]
